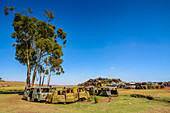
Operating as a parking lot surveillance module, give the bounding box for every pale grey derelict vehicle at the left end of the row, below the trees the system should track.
[23,86,52,101]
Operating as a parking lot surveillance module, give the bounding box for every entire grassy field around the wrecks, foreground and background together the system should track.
[0,82,170,113]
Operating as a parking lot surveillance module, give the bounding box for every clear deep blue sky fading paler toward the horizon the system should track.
[0,0,170,84]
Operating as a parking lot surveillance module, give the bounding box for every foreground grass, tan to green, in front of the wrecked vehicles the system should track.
[0,94,170,113]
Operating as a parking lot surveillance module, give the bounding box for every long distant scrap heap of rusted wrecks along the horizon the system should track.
[78,77,165,89]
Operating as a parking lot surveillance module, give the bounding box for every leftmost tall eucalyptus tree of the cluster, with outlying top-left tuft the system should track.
[4,7,38,86]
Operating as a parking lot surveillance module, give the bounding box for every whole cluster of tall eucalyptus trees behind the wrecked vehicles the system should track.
[4,7,67,87]
